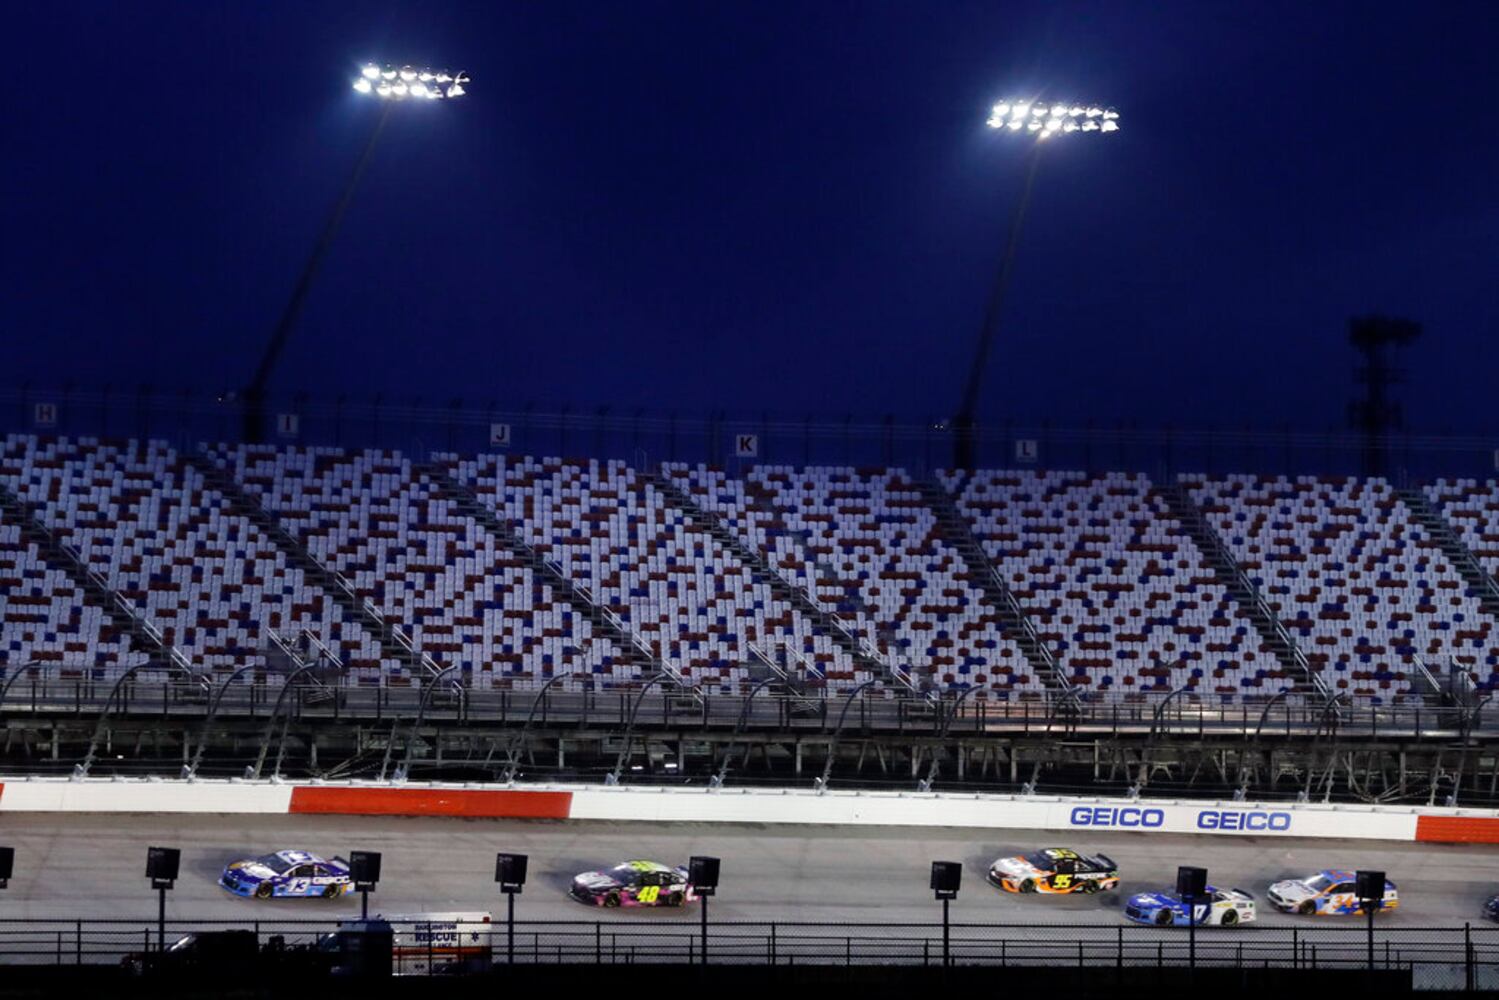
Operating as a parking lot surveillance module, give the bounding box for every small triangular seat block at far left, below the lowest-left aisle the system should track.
[0,519,148,682]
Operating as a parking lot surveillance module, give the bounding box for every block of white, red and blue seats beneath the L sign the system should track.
[940,471,1271,699]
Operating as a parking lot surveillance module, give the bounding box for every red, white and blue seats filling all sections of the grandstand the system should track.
[0,435,1499,703]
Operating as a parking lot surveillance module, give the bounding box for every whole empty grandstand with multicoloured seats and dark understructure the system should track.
[0,419,1499,799]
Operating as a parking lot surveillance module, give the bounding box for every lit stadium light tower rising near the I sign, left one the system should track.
[244,63,469,444]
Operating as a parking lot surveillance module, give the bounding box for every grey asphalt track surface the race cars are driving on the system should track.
[0,813,1499,934]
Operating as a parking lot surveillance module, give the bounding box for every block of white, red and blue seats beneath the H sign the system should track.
[0,435,388,682]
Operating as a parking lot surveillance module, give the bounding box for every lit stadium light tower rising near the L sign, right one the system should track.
[952,99,1120,469]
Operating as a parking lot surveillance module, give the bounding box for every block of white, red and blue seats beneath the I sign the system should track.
[211,445,619,690]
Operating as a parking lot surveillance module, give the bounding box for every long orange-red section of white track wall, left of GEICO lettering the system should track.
[291,786,573,820]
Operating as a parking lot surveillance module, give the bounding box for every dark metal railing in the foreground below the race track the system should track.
[0,910,1499,990]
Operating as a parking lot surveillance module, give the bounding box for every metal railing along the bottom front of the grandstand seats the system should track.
[0,664,1475,739]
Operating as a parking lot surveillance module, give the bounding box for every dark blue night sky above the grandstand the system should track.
[0,0,1499,430]
